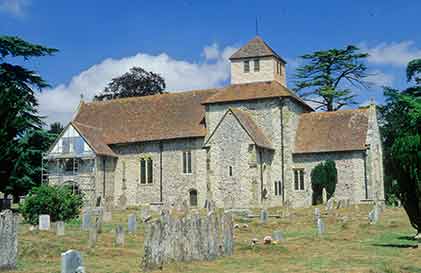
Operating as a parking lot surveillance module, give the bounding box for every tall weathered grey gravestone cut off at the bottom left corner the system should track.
[0,210,18,271]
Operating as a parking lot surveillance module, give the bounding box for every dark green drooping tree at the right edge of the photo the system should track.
[380,60,421,234]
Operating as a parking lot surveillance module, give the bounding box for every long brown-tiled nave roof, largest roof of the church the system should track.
[74,90,216,144]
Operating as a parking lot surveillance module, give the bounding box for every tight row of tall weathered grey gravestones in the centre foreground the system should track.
[142,211,234,269]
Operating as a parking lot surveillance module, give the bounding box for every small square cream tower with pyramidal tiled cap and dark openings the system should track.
[230,36,286,87]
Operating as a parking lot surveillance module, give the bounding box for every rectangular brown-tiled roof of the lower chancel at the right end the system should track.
[294,109,369,153]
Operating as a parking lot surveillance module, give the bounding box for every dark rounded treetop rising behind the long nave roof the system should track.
[94,67,165,101]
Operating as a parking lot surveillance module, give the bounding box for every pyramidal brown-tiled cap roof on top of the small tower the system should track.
[230,36,286,63]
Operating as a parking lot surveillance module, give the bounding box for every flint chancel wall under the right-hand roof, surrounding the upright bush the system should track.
[292,151,365,207]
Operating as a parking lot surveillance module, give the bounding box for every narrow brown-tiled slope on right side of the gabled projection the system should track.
[230,108,273,150]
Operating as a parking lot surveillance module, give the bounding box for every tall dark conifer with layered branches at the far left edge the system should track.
[0,36,57,193]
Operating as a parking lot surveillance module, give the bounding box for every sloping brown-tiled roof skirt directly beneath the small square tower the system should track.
[203,81,313,111]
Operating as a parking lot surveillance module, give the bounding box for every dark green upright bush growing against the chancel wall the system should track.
[310,160,338,199]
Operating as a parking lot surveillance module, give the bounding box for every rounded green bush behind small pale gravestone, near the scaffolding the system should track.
[20,184,83,225]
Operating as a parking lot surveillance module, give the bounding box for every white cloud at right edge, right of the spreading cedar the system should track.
[360,41,421,66]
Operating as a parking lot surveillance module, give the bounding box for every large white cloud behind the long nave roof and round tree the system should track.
[38,44,236,123]
